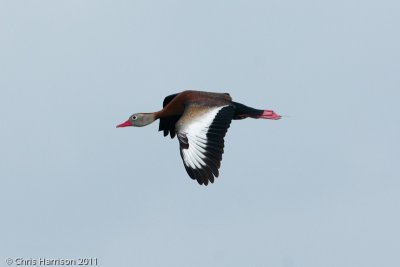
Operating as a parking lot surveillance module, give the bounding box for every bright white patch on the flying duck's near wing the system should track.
[180,106,226,169]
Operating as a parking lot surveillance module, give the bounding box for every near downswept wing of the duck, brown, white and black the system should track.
[177,105,234,185]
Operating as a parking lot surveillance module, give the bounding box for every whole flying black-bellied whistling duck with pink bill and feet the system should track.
[117,91,281,185]
